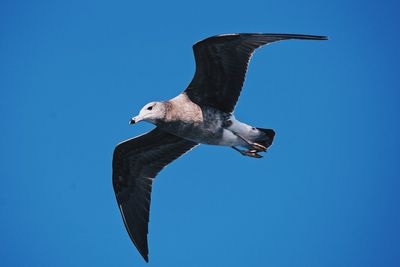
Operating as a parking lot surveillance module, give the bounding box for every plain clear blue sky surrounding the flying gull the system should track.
[0,0,400,266]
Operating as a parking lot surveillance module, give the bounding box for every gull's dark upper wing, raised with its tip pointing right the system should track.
[185,33,327,112]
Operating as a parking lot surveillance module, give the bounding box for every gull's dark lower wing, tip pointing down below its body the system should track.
[112,128,197,261]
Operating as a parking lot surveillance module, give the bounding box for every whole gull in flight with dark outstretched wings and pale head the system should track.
[112,33,328,262]
